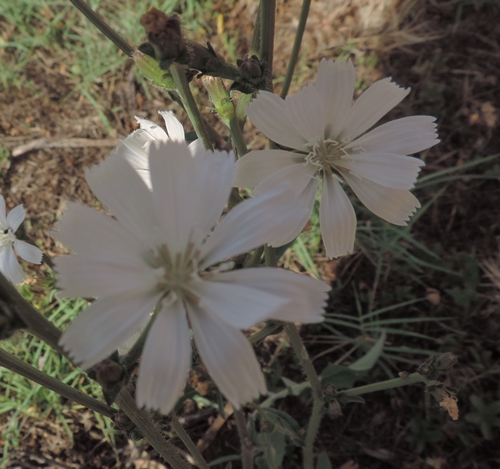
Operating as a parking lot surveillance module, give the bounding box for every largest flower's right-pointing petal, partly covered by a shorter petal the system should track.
[210,267,330,323]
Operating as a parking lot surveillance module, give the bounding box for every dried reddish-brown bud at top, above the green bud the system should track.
[140,8,189,63]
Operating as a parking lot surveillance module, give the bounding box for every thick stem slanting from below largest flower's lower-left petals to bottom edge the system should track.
[116,388,192,469]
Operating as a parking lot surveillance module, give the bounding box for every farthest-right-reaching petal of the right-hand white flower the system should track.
[345,116,439,155]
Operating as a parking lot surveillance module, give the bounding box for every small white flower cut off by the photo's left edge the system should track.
[0,195,43,284]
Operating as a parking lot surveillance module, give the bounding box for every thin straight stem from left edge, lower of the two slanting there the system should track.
[0,348,116,418]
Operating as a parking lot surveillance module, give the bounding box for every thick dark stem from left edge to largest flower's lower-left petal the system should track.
[0,274,63,353]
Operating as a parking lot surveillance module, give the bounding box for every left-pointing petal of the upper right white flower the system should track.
[233,150,305,188]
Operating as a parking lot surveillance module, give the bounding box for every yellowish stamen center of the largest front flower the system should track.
[154,244,200,303]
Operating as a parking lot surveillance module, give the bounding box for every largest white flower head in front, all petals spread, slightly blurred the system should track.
[54,141,329,413]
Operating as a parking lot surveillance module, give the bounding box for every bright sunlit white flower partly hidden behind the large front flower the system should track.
[118,111,205,188]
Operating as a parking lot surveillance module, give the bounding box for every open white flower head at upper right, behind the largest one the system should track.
[234,59,439,258]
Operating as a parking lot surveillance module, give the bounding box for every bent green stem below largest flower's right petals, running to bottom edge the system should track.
[285,323,324,469]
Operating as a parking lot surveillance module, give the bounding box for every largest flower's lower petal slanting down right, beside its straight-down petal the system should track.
[188,305,267,409]
